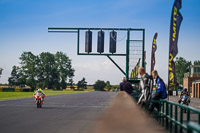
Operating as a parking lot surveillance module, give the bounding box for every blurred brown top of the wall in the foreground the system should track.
[93,92,167,133]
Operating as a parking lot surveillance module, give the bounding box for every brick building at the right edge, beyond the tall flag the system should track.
[183,65,200,93]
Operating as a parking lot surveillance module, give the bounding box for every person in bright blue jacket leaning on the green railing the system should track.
[149,70,167,113]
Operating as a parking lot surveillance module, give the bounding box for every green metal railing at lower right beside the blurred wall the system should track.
[133,91,200,133]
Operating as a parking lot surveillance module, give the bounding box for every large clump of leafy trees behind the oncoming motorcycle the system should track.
[8,52,75,90]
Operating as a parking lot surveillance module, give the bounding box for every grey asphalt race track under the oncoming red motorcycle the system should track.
[0,92,117,133]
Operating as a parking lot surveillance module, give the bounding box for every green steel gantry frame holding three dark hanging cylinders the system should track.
[48,27,145,83]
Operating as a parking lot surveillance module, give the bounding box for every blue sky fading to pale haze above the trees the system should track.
[0,0,200,84]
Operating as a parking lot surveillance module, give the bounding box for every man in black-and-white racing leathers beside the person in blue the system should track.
[137,67,153,107]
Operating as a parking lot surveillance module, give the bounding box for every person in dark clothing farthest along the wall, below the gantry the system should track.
[120,77,133,95]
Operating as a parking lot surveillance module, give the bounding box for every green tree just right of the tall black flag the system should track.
[175,57,192,85]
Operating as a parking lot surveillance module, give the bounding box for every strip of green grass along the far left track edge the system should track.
[0,90,85,100]
